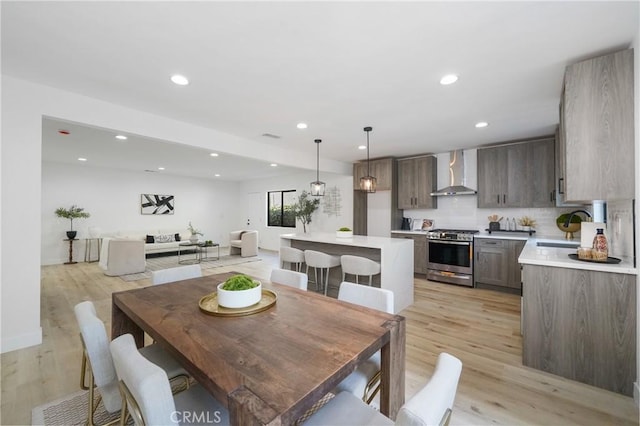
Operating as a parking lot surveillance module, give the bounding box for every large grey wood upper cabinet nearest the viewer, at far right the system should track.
[558,49,635,202]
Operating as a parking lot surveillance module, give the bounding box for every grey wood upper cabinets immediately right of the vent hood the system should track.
[478,137,555,208]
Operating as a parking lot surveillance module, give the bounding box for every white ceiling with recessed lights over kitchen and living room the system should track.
[1,1,639,179]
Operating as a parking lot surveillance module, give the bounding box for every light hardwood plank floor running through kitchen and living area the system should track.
[0,251,639,425]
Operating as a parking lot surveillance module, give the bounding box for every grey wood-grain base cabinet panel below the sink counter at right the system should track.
[522,264,637,396]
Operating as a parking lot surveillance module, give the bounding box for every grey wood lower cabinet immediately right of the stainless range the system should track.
[473,238,526,294]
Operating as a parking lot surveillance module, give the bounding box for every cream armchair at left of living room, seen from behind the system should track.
[99,238,147,277]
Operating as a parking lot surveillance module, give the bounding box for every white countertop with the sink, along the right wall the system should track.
[518,238,638,275]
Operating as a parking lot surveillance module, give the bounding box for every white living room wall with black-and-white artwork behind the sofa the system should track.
[41,162,239,265]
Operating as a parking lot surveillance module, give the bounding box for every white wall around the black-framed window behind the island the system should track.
[238,171,353,250]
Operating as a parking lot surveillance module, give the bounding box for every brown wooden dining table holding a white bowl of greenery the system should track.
[111,273,405,426]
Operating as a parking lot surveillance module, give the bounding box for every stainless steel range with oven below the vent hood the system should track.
[427,229,478,287]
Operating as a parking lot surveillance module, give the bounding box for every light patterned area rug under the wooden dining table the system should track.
[31,391,334,426]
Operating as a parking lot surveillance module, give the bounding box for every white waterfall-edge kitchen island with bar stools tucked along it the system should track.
[280,233,413,313]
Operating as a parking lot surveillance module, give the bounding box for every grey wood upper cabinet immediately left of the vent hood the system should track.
[398,155,438,209]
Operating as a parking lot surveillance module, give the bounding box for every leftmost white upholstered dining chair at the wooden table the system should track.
[74,301,189,425]
